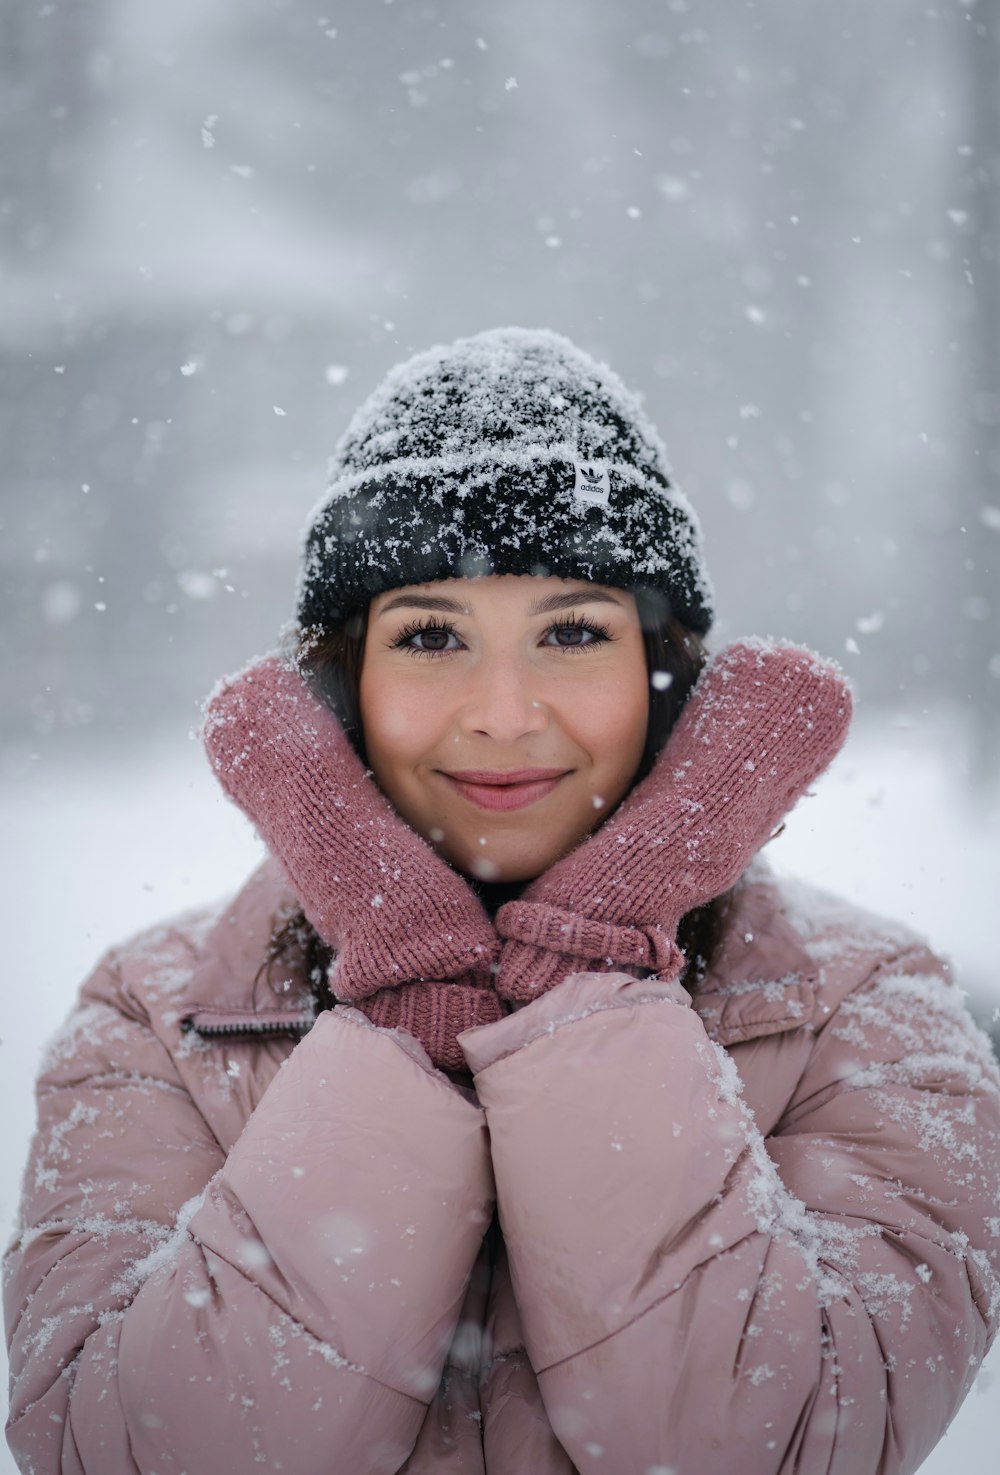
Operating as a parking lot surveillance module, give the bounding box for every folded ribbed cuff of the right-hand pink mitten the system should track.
[496,901,684,1003]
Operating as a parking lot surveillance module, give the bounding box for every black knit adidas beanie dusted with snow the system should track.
[298,327,712,634]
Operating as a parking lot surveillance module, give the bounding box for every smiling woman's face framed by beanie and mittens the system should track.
[360,574,649,881]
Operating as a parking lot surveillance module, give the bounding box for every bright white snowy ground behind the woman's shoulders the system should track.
[0,720,1000,1475]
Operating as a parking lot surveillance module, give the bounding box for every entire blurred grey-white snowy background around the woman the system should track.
[0,0,1000,1475]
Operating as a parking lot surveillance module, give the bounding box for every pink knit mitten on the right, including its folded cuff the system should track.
[497,640,851,1002]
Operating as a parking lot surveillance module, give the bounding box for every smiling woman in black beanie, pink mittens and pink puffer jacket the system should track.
[7,330,1000,1475]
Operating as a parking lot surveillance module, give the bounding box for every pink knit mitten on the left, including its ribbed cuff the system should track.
[204,656,503,1069]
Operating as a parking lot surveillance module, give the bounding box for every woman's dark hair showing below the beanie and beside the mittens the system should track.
[278,589,729,1007]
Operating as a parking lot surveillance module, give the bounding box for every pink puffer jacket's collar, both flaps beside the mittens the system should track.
[181,857,816,1046]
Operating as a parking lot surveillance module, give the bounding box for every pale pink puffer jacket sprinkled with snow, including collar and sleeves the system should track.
[6,861,1000,1475]
